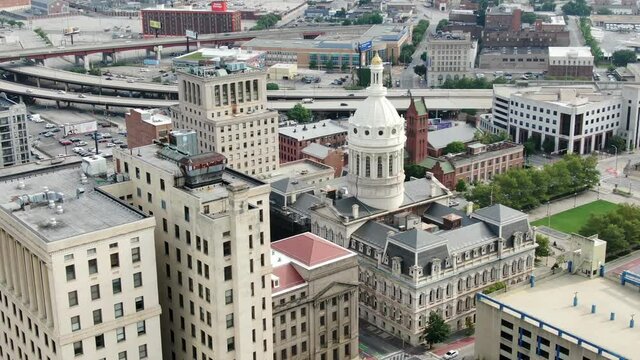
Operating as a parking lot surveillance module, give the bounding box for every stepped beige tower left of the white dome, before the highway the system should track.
[172,64,280,175]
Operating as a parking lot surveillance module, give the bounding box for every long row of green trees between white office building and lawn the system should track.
[466,154,600,210]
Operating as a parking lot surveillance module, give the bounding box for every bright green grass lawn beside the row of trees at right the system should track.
[531,200,618,234]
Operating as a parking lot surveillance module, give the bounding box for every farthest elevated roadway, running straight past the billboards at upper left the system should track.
[0,24,371,62]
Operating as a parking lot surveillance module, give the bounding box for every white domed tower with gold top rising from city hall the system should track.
[348,54,406,210]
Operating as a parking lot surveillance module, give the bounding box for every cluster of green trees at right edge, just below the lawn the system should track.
[579,204,640,255]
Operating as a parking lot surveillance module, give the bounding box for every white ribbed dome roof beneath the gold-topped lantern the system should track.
[349,96,403,128]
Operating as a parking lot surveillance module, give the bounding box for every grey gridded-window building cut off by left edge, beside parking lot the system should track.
[0,96,31,168]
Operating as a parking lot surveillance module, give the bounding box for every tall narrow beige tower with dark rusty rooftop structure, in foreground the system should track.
[105,137,273,360]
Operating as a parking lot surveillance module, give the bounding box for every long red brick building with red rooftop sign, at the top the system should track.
[140,6,242,36]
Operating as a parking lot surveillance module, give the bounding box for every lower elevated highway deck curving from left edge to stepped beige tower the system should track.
[0,80,178,108]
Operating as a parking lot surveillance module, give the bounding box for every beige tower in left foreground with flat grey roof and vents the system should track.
[0,166,162,360]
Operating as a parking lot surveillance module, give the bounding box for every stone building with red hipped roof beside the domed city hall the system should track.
[271,233,358,360]
